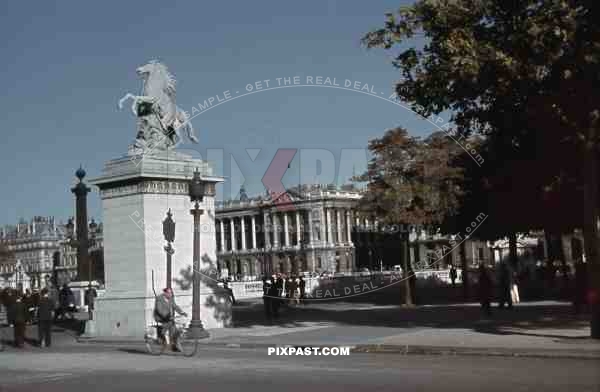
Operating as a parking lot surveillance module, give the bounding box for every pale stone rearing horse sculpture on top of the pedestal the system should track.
[119,60,198,152]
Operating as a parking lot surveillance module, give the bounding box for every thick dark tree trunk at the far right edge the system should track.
[583,139,600,339]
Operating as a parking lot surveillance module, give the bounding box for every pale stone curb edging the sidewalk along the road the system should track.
[77,338,600,360]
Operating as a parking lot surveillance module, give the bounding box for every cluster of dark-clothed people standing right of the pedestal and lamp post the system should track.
[263,274,306,321]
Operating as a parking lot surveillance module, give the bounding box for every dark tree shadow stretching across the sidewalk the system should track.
[233,301,589,339]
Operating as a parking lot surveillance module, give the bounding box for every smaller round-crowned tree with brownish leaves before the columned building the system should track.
[355,128,462,305]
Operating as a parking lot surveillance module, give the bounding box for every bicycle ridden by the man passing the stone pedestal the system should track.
[144,316,200,357]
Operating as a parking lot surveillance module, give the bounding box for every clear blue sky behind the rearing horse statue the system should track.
[0,0,440,224]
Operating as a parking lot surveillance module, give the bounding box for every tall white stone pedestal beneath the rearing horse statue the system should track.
[90,151,231,339]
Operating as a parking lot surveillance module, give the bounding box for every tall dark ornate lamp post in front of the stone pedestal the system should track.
[189,168,209,339]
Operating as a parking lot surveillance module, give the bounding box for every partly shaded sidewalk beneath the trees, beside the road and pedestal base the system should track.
[81,302,600,360]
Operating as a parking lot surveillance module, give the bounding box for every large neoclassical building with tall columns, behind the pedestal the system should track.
[215,185,361,280]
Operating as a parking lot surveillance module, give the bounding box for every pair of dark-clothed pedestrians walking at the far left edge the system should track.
[2,288,55,348]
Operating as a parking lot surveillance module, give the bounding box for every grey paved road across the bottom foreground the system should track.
[0,348,600,392]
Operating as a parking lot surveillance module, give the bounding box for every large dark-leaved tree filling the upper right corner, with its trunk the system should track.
[364,0,600,338]
